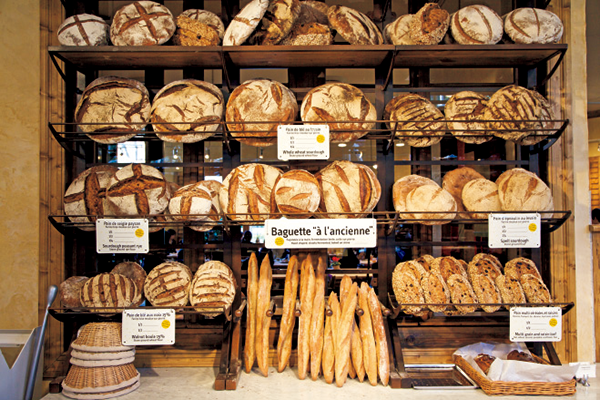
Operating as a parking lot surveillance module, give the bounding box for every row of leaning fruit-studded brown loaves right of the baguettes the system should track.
[392,253,552,317]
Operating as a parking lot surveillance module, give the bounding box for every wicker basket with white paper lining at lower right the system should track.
[454,355,577,396]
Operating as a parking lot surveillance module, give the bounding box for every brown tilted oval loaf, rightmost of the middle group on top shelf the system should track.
[327,5,383,45]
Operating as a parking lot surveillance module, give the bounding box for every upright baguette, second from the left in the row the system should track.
[256,257,273,376]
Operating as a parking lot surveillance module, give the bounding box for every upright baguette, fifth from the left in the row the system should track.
[310,257,326,381]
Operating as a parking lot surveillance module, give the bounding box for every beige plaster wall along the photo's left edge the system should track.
[0,0,40,329]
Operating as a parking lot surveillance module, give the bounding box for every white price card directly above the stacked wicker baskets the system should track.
[121,309,175,346]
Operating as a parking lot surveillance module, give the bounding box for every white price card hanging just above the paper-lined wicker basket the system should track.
[510,307,562,342]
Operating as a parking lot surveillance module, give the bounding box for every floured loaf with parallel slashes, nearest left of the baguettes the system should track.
[190,261,236,318]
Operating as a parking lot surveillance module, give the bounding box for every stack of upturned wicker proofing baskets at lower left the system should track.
[62,322,140,399]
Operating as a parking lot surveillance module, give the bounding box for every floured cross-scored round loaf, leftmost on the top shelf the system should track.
[57,14,109,46]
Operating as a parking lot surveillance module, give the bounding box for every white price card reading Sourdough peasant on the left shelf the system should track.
[96,219,150,254]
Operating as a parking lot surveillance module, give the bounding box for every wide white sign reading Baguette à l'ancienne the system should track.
[265,218,377,249]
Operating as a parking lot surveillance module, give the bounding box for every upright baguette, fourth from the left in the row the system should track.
[298,254,315,379]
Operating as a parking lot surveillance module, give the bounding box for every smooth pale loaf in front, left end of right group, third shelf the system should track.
[406,185,457,225]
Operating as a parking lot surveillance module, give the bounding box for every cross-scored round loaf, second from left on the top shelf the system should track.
[110,1,176,46]
